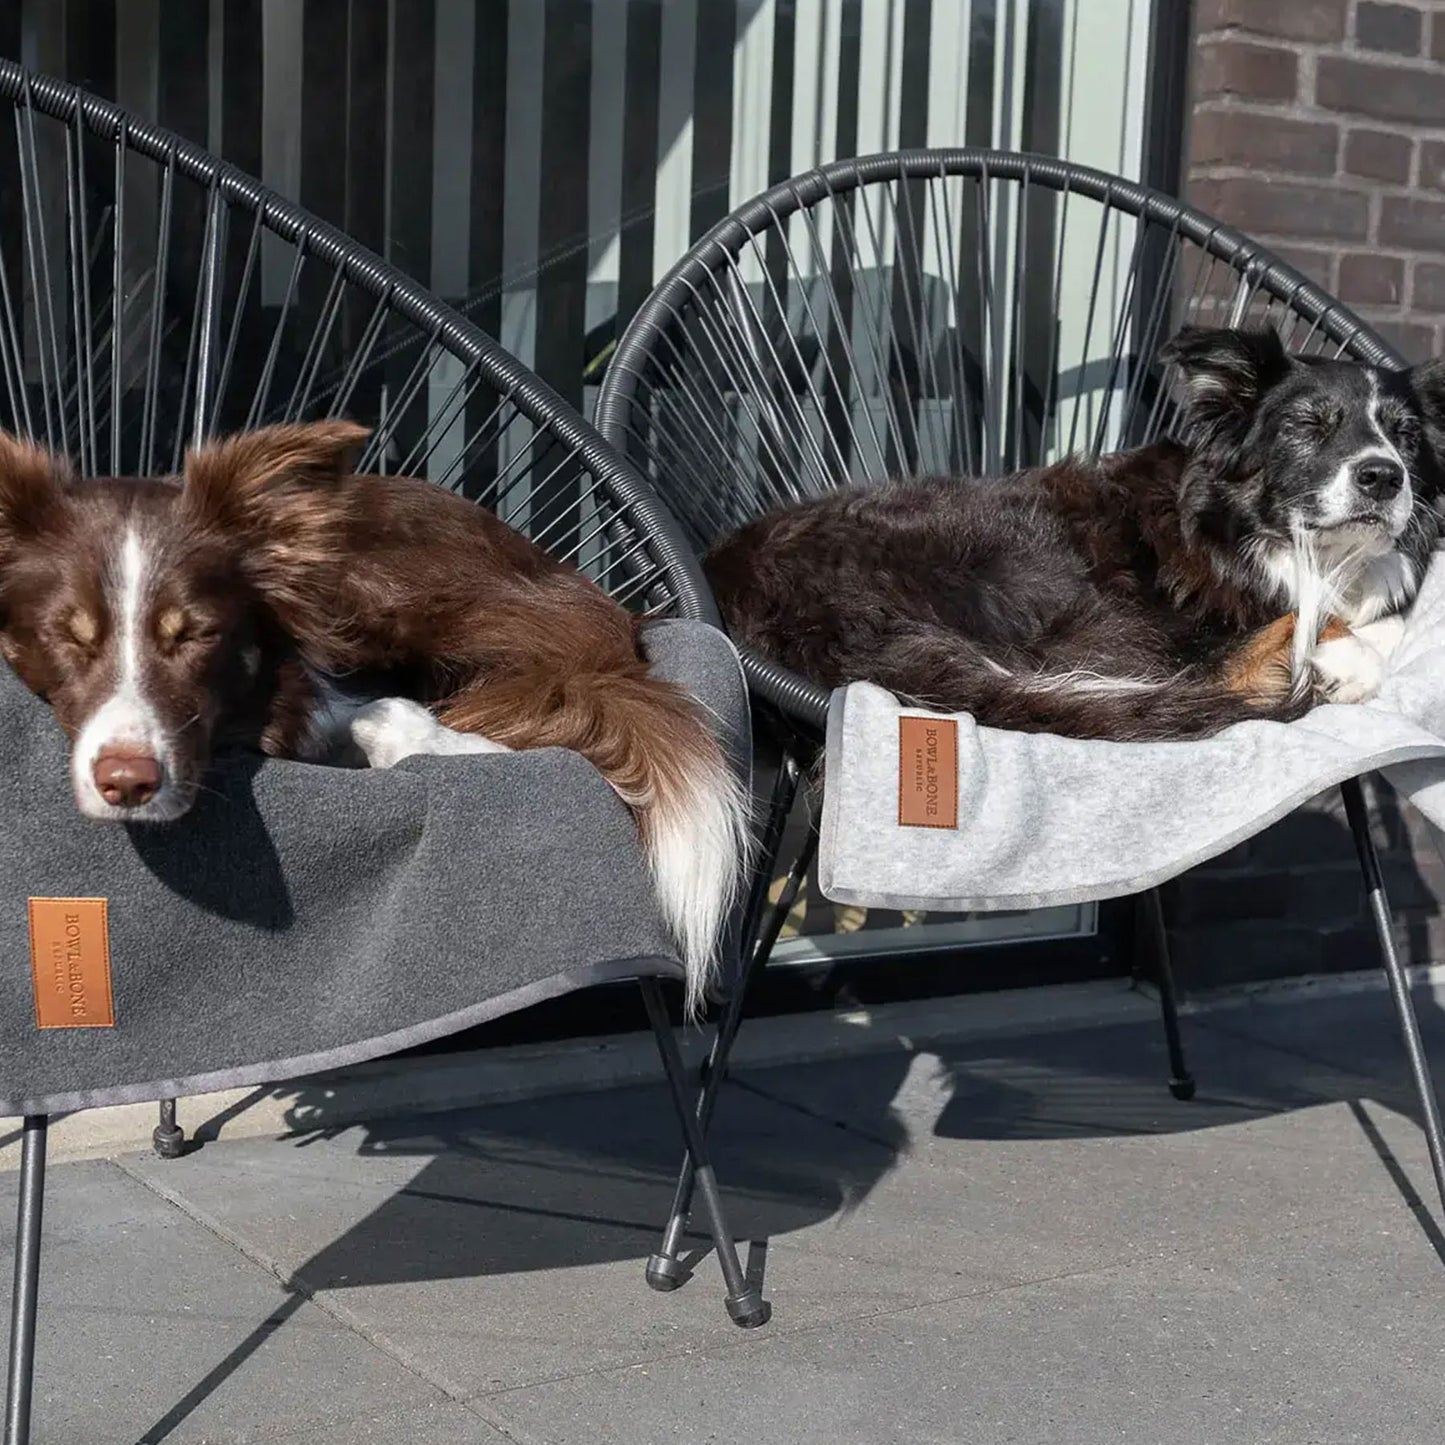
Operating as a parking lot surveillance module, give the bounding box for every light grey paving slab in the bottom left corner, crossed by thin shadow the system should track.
[0,1163,453,1445]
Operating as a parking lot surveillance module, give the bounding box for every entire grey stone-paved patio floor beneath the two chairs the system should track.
[16,996,1445,1445]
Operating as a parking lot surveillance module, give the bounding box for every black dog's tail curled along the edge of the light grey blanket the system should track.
[877,618,1308,741]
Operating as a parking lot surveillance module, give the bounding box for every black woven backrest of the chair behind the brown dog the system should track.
[0,61,715,618]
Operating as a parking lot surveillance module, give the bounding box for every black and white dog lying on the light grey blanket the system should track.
[707,327,1445,740]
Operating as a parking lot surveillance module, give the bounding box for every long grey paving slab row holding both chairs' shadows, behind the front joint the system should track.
[126,1030,1445,1416]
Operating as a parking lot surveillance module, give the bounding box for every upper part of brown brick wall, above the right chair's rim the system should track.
[1186,0,1445,360]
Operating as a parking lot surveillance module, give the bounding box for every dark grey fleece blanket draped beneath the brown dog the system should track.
[0,623,750,1116]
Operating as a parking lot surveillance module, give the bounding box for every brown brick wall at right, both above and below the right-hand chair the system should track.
[1165,0,1445,988]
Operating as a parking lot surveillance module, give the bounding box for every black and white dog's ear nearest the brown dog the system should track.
[1159,327,1293,444]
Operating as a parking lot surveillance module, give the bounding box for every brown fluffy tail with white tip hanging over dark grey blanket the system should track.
[439,660,750,1014]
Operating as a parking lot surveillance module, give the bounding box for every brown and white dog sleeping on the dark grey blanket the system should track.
[0,420,747,1009]
